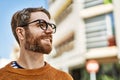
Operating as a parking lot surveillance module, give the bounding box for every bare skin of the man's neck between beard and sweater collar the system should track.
[17,50,45,69]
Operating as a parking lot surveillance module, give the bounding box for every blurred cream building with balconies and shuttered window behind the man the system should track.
[47,0,120,80]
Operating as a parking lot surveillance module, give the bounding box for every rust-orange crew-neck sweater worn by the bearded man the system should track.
[0,63,73,80]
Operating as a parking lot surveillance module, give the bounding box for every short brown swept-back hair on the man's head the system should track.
[11,7,51,44]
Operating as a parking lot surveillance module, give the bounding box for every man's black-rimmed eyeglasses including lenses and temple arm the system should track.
[22,19,56,33]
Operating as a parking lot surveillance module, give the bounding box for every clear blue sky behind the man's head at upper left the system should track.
[0,0,48,59]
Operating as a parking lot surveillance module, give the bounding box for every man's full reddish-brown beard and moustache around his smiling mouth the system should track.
[25,30,52,54]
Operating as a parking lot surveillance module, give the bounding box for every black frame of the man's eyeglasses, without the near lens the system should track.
[21,19,56,33]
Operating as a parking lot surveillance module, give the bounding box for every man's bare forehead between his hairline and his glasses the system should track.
[30,11,49,22]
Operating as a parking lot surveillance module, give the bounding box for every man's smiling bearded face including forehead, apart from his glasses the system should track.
[24,12,52,54]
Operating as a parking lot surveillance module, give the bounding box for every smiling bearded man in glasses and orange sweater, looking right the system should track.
[0,7,72,80]
